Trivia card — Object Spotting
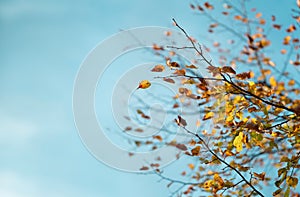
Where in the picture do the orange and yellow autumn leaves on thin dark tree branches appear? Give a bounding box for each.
[127,1,300,196]
